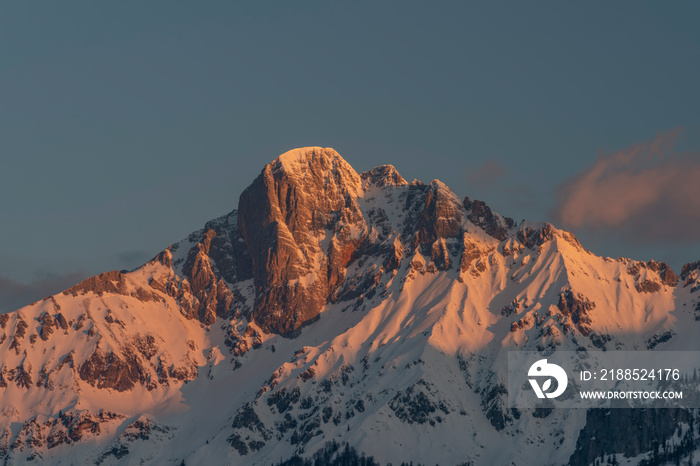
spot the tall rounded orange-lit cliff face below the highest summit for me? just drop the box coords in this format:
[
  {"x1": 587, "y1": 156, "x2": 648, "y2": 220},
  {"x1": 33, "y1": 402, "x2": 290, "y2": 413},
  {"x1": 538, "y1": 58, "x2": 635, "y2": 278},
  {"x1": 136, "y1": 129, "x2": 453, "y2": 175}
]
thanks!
[{"x1": 238, "y1": 148, "x2": 367, "y2": 334}]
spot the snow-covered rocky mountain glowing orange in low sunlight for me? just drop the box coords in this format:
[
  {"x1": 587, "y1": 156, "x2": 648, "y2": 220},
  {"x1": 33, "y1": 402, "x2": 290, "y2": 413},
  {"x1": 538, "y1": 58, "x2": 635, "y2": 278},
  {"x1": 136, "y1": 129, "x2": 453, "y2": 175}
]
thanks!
[{"x1": 0, "y1": 147, "x2": 700, "y2": 465}]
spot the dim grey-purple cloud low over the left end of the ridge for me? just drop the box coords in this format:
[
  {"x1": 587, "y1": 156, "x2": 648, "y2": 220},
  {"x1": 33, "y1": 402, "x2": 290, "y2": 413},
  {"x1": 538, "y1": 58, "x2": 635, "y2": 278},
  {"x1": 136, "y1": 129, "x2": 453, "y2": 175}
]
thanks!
[{"x1": 0, "y1": 272, "x2": 86, "y2": 314}]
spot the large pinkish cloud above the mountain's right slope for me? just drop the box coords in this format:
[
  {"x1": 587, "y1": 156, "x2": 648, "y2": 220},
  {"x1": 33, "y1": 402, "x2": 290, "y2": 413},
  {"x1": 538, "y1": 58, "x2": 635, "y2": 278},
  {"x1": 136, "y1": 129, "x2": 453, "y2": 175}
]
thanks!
[{"x1": 553, "y1": 128, "x2": 700, "y2": 242}]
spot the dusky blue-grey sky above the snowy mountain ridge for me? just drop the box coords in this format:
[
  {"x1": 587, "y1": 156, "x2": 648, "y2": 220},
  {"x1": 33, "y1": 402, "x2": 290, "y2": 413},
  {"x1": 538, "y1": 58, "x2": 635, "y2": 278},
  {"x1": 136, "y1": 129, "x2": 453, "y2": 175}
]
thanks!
[{"x1": 0, "y1": 1, "x2": 700, "y2": 310}]
